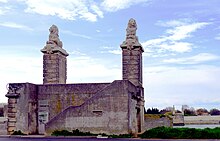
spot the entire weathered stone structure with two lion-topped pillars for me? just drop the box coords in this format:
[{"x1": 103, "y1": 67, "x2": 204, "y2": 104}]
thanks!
[{"x1": 6, "y1": 19, "x2": 144, "y2": 134}]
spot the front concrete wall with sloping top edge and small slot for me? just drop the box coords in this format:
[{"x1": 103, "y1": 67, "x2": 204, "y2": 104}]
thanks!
[{"x1": 46, "y1": 81, "x2": 137, "y2": 134}]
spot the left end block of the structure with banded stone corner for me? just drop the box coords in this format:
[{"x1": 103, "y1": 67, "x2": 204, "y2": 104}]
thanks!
[{"x1": 6, "y1": 83, "x2": 37, "y2": 134}]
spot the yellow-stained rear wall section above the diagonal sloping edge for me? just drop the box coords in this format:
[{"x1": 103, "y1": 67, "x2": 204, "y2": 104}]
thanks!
[{"x1": 38, "y1": 83, "x2": 110, "y2": 120}]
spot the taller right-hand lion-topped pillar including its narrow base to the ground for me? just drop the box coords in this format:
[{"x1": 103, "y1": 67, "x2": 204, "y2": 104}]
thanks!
[{"x1": 121, "y1": 18, "x2": 144, "y2": 132}]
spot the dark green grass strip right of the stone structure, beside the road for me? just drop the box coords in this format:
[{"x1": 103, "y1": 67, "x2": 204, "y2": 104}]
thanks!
[{"x1": 140, "y1": 127, "x2": 220, "y2": 139}]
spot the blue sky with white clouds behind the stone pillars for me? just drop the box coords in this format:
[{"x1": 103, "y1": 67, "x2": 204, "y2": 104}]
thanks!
[{"x1": 0, "y1": 0, "x2": 220, "y2": 109}]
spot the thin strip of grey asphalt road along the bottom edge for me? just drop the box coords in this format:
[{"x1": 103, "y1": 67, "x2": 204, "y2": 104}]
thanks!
[{"x1": 0, "y1": 137, "x2": 216, "y2": 141}]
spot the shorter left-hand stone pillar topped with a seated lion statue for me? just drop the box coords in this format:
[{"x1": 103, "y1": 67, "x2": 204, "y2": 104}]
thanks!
[{"x1": 41, "y1": 25, "x2": 69, "y2": 84}]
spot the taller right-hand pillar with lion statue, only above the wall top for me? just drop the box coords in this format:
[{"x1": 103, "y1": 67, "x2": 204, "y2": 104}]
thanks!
[{"x1": 121, "y1": 19, "x2": 144, "y2": 87}]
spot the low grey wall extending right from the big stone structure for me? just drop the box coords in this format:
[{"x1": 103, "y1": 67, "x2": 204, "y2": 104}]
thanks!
[{"x1": 144, "y1": 117, "x2": 173, "y2": 130}]
